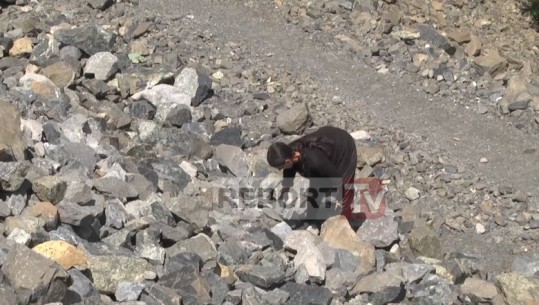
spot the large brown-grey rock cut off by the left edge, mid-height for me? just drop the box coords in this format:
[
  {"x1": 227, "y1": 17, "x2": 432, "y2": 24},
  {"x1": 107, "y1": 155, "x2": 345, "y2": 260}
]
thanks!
[{"x1": 0, "y1": 98, "x2": 26, "y2": 162}]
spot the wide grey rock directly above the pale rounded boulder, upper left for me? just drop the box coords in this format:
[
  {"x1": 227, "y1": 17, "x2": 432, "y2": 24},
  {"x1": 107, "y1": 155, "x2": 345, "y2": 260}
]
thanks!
[{"x1": 53, "y1": 24, "x2": 116, "y2": 56}]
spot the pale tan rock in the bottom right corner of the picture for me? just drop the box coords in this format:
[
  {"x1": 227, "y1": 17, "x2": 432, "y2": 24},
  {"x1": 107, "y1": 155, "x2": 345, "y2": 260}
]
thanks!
[{"x1": 496, "y1": 273, "x2": 539, "y2": 305}]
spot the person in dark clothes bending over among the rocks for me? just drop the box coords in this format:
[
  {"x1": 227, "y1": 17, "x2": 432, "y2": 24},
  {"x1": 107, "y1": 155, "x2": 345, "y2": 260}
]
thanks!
[{"x1": 267, "y1": 126, "x2": 357, "y2": 221}]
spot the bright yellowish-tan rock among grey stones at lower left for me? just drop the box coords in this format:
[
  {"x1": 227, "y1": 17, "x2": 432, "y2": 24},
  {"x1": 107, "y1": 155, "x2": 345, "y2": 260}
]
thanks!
[{"x1": 32, "y1": 240, "x2": 87, "y2": 270}]
